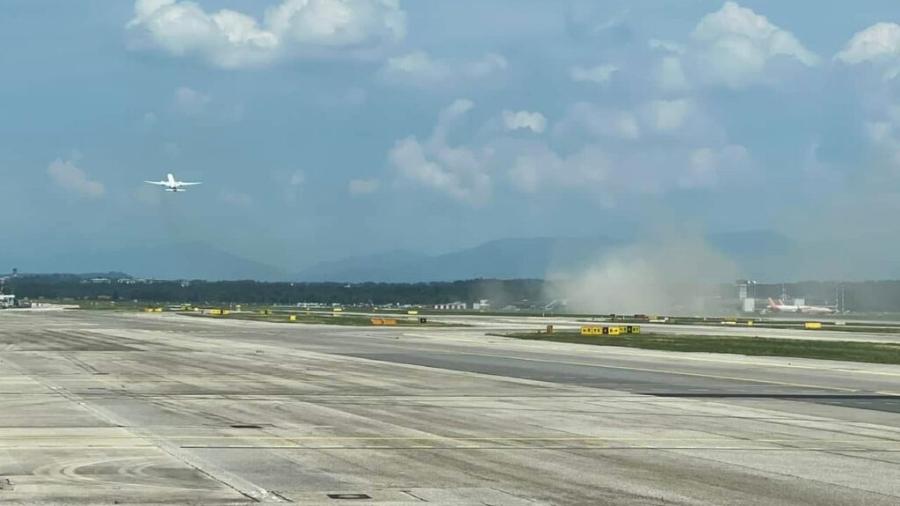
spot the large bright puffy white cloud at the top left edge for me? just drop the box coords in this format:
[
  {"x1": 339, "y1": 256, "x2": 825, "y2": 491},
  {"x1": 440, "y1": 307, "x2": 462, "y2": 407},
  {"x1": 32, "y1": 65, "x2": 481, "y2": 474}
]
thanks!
[{"x1": 126, "y1": 0, "x2": 406, "y2": 69}]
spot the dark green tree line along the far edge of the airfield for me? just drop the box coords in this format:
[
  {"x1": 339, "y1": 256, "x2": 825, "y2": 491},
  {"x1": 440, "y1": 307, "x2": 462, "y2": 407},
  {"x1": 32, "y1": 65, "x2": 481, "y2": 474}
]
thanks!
[{"x1": 5, "y1": 273, "x2": 900, "y2": 312}]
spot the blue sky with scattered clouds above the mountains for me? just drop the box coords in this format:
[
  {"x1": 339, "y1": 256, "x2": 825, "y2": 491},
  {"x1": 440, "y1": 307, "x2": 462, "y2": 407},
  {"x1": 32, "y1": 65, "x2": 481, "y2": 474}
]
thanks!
[{"x1": 0, "y1": 0, "x2": 900, "y2": 276}]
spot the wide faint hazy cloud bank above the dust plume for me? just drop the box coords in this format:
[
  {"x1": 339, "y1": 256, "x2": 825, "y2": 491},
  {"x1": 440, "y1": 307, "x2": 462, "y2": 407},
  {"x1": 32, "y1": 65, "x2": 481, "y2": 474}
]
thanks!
[{"x1": 528, "y1": 93, "x2": 752, "y2": 198}]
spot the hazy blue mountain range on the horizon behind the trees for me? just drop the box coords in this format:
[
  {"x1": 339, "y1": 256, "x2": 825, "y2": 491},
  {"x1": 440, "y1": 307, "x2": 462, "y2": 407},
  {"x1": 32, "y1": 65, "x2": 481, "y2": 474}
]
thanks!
[{"x1": 2, "y1": 231, "x2": 792, "y2": 282}]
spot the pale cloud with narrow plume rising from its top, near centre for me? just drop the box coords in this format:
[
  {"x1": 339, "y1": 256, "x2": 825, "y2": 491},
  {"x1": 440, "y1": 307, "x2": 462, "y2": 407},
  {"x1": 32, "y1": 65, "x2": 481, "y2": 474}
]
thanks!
[{"x1": 388, "y1": 100, "x2": 491, "y2": 205}]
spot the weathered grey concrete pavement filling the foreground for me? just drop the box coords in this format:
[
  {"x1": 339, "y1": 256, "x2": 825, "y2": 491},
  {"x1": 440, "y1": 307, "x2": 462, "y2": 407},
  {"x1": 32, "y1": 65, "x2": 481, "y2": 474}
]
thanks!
[{"x1": 0, "y1": 311, "x2": 900, "y2": 505}]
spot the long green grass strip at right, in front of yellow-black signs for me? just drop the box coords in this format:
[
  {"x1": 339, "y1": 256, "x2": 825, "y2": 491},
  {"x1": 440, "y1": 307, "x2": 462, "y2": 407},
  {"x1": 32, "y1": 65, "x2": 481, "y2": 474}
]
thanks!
[{"x1": 504, "y1": 332, "x2": 900, "y2": 364}]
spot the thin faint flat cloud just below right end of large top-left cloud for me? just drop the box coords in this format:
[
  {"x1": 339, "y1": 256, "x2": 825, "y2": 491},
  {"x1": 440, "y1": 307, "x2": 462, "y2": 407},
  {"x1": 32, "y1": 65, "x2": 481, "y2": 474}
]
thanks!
[{"x1": 379, "y1": 51, "x2": 508, "y2": 87}]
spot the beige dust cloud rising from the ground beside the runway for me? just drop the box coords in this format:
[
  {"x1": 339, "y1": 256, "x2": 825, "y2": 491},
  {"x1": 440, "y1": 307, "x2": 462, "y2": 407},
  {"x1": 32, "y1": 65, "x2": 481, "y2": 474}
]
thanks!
[{"x1": 548, "y1": 231, "x2": 739, "y2": 315}]
